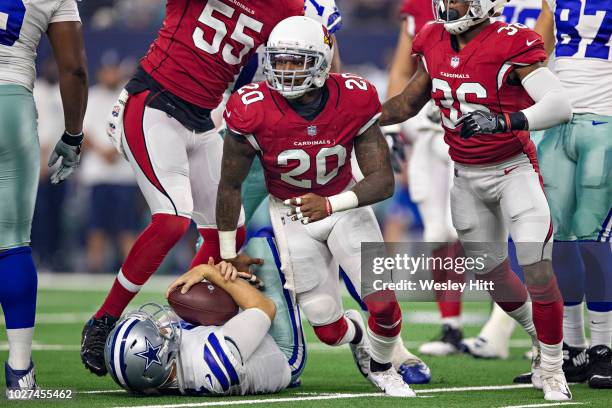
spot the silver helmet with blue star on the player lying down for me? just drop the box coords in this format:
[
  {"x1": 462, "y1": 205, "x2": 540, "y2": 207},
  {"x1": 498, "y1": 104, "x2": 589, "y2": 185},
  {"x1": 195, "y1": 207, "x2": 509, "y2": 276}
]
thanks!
[{"x1": 104, "y1": 303, "x2": 181, "y2": 393}]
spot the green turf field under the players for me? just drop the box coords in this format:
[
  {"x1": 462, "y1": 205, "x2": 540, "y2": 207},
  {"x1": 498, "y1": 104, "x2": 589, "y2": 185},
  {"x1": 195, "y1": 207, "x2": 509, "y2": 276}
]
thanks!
[{"x1": 0, "y1": 287, "x2": 612, "y2": 408}]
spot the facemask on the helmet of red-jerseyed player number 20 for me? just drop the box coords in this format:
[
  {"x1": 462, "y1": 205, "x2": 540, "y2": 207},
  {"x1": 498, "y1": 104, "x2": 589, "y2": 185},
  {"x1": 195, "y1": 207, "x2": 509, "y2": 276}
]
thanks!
[{"x1": 264, "y1": 47, "x2": 329, "y2": 99}]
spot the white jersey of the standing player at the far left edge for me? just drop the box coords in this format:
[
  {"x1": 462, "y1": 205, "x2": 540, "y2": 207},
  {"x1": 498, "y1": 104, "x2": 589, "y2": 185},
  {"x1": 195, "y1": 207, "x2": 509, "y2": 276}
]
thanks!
[{"x1": 0, "y1": 0, "x2": 81, "y2": 90}]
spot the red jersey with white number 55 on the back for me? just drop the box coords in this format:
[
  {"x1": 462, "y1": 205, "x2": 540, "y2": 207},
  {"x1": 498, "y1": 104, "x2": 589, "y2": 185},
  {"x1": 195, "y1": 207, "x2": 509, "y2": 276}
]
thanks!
[{"x1": 140, "y1": 0, "x2": 304, "y2": 109}]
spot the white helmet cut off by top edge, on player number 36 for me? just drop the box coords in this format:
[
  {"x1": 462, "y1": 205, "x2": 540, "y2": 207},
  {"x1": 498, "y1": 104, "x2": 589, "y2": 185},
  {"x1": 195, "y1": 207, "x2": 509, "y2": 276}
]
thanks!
[{"x1": 433, "y1": 0, "x2": 510, "y2": 35}]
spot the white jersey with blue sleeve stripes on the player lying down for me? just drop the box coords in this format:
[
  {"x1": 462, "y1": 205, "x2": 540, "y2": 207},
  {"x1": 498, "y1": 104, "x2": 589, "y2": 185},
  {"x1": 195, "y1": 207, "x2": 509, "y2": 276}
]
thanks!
[{"x1": 177, "y1": 326, "x2": 291, "y2": 395}]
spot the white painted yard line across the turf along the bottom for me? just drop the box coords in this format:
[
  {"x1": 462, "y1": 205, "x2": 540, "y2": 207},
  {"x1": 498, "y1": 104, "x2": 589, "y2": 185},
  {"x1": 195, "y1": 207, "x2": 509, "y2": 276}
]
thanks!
[{"x1": 97, "y1": 384, "x2": 531, "y2": 408}]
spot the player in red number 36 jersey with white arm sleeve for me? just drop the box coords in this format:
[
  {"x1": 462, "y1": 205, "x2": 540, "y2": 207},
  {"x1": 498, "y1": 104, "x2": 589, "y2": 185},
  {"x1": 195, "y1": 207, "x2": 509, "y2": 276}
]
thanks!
[{"x1": 381, "y1": 0, "x2": 572, "y2": 401}]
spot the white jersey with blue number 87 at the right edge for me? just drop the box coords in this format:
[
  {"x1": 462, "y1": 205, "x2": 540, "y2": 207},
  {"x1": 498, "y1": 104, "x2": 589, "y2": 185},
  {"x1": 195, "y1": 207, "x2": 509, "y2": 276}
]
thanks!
[{"x1": 547, "y1": 0, "x2": 612, "y2": 116}]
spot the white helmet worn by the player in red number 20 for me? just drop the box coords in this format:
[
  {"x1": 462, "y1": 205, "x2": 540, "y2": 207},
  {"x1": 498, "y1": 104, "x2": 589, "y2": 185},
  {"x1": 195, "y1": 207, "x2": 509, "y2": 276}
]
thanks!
[{"x1": 264, "y1": 16, "x2": 333, "y2": 99}]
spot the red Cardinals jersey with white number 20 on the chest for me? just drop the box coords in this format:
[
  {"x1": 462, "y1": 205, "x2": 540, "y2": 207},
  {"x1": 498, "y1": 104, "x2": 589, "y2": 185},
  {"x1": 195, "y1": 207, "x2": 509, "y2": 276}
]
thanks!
[{"x1": 224, "y1": 74, "x2": 382, "y2": 200}]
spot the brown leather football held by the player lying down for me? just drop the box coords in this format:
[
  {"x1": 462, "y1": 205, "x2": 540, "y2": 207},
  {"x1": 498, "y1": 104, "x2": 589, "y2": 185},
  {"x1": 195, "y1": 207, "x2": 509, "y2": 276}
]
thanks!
[{"x1": 168, "y1": 282, "x2": 238, "y2": 326}]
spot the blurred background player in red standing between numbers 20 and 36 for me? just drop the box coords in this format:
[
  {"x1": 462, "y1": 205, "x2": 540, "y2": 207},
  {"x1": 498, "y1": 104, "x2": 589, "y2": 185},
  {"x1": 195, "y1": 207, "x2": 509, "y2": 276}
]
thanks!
[{"x1": 383, "y1": 0, "x2": 466, "y2": 356}]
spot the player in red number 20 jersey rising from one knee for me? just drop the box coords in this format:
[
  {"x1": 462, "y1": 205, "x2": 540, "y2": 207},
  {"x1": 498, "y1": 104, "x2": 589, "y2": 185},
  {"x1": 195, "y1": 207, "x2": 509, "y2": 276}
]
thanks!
[{"x1": 217, "y1": 17, "x2": 415, "y2": 397}]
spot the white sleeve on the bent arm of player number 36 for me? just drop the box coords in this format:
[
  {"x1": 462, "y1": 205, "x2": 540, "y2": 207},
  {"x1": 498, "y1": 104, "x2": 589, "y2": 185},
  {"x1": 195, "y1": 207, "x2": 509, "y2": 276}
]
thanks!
[{"x1": 522, "y1": 67, "x2": 572, "y2": 130}]
